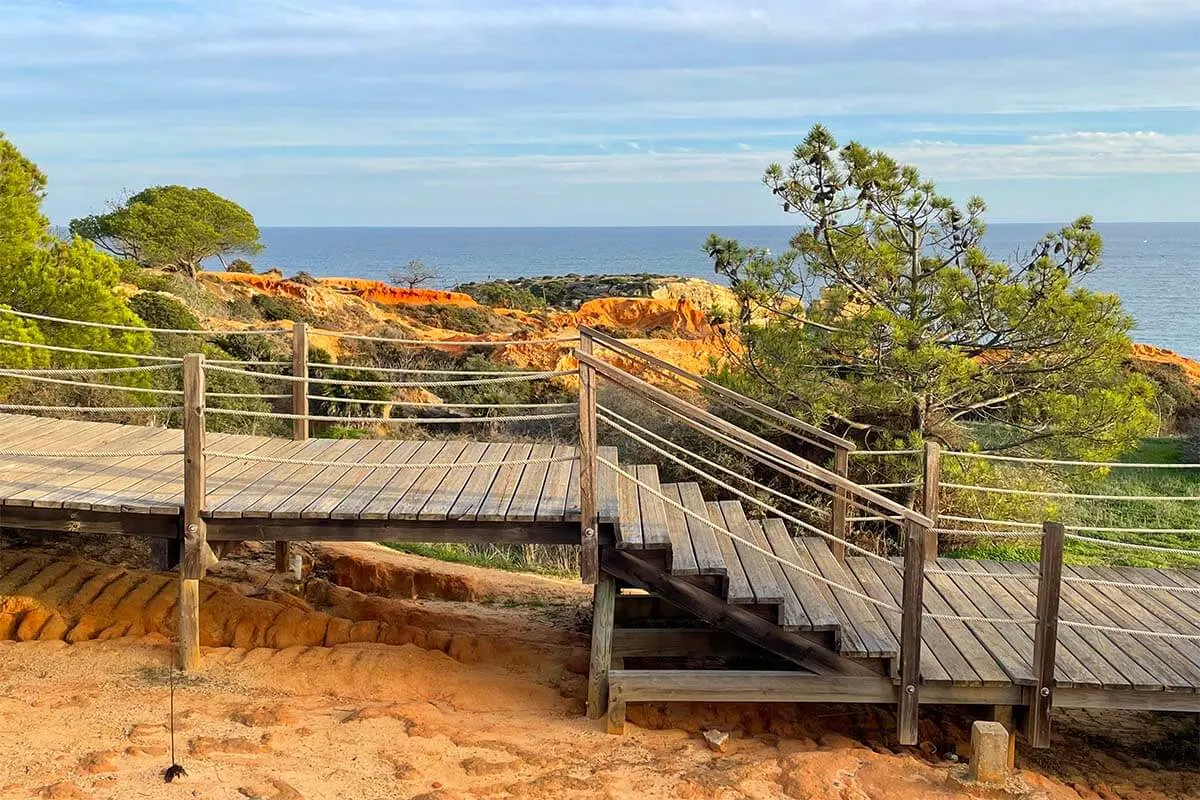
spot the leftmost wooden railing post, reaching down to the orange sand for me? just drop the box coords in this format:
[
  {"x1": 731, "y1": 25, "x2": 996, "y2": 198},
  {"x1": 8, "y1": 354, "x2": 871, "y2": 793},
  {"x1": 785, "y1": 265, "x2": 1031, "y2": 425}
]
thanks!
[{"x1": 179, "y1": 354, "x2": 208, "y2": 670}]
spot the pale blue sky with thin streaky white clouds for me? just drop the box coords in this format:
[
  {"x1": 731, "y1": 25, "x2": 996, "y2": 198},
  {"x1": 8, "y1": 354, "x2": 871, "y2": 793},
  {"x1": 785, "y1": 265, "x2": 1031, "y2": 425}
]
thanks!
[{"x1": 0, "y1": 0, "x2": 1200, "y2": 225}]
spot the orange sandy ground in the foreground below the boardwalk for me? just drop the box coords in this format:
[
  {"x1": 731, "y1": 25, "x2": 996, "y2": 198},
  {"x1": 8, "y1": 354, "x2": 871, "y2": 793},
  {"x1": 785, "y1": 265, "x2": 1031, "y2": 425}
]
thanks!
[{"x1": 0, "y1": 537, "x2": 1200, "y2": 800}]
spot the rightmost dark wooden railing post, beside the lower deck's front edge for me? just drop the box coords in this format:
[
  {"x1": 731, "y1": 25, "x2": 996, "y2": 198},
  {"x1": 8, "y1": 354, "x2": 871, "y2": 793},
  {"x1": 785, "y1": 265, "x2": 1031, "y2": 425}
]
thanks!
[{"x1": 1026, "y1": 522, "x2": 1066, "y2": 747}]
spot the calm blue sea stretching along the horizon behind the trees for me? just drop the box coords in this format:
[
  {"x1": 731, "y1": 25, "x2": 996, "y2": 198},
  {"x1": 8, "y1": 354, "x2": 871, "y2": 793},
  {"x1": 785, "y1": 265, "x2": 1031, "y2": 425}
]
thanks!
[{"x1": 243, "y1": 223, "x2": 1200, "y2": 359}]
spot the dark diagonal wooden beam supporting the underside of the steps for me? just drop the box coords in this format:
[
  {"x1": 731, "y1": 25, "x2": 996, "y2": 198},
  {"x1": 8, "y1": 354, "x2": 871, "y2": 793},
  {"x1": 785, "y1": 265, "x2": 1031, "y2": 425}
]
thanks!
[{"x1": 600, "y1": 548, "x2": 875, "y2": 676}]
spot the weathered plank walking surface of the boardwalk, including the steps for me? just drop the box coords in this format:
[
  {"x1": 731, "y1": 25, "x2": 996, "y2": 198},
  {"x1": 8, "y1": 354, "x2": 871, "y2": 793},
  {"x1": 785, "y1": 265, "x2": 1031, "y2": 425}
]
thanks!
[{"x1": 0, "y1": 414, "x2": 1200, "y2": 710}]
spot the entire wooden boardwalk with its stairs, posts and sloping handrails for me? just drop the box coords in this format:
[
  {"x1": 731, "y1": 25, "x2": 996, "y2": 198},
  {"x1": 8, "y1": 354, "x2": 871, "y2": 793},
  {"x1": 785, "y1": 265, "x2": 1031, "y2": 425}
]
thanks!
[{"x1": 0, "y1": 326, "x2": 1200, "y2": 746}]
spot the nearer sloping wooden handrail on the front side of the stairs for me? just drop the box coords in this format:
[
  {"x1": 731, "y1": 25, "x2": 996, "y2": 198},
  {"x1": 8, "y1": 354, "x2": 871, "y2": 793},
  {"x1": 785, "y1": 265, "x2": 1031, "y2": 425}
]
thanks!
[{"x1": 575, "y1": 350, "x2": 932, "y2": 528}]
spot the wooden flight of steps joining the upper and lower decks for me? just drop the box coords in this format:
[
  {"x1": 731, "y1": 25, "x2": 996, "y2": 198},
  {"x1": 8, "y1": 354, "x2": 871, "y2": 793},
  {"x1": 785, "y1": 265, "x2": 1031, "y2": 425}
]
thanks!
[{"x1": 599, "y1": 449, "x2": 899, "y2": 675}]
